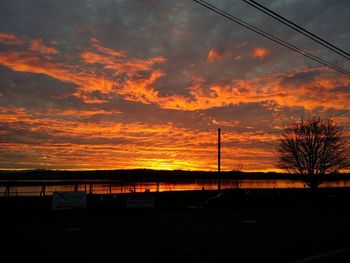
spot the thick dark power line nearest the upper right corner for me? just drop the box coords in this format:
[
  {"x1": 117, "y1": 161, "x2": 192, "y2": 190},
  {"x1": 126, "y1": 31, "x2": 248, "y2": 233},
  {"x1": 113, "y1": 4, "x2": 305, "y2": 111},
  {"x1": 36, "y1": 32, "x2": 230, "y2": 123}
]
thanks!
[{"x1": 242, "y1": 0, "x2": 350, "y2": 60}]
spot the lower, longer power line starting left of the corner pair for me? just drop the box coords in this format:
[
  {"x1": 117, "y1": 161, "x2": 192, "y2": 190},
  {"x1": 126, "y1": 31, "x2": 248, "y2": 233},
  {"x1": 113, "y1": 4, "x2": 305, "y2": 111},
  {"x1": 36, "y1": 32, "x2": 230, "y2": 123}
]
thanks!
[{"x1": 193, "y1": 0, "x2": 350, "y2": 76}]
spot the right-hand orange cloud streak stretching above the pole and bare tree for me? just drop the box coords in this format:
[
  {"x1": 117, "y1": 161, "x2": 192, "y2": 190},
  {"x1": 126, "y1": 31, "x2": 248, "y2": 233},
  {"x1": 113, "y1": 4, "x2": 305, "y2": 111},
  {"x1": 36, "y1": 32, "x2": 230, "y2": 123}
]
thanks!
[{"x1": 157, "y1": 69, "x2": 350, "y2": 110}]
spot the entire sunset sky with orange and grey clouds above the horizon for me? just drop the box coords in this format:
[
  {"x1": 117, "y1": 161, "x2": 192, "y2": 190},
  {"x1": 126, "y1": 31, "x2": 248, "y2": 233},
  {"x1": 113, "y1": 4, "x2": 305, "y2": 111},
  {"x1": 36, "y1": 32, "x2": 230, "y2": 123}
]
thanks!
[{"x1": 0, "y1": 0, "x2": 350, "y2": 171}]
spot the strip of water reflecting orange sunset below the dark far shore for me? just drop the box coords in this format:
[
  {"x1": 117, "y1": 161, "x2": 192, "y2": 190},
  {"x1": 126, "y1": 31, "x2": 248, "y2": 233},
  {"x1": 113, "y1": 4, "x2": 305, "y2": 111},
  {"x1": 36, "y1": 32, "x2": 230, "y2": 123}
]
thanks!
[{"x1": 0, "y1": 179, "x2": 350, "y2": 196}]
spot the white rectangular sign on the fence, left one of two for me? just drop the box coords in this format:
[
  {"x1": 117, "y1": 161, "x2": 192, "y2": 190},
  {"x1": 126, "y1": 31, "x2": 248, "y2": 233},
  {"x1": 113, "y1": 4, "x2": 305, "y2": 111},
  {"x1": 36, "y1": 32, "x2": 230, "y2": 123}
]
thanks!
[{"x1": 52, "y1": 192, "x2": 86, "y2": 210}]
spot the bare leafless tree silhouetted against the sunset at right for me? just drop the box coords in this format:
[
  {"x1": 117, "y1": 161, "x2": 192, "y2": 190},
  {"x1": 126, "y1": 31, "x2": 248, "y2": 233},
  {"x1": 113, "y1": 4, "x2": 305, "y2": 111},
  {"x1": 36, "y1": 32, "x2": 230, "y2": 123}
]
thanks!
[{"x1": 277, "y1": 118, "x2": 350, "y2": 188}]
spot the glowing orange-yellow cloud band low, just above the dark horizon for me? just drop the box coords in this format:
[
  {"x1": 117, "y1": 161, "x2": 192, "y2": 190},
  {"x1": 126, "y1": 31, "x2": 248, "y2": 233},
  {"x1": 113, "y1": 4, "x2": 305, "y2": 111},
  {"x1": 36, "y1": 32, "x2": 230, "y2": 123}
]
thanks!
[{"x1": 0, "y1": 108, "x2": 276, "y2": 170}]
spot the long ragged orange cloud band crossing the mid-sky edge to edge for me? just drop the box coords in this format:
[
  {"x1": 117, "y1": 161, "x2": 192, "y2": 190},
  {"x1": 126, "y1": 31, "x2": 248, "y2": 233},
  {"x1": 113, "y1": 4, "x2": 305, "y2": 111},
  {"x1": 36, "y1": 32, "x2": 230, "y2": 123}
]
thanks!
[{"x1": 0, "y1": 33, "x2": 349, "y2": 114}]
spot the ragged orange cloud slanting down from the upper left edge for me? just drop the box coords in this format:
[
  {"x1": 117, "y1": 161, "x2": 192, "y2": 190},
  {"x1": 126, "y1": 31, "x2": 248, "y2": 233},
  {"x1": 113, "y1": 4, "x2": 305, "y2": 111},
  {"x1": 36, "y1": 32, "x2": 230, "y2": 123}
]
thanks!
[{"x1": 0, "y1": 35, "x2": 166, "y2": 103}]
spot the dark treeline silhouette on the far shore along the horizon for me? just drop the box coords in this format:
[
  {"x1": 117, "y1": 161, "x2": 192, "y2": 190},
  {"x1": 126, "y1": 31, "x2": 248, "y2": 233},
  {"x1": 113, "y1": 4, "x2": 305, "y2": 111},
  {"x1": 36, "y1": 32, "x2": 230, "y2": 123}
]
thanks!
[{"x1": 0, "y1": 169, "x2": 350, "y2": 181}]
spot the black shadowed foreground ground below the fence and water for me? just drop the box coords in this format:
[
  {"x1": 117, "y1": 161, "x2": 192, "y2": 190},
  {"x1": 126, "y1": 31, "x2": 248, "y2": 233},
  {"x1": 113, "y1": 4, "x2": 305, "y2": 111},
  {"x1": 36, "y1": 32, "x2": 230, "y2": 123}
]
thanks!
[{"x1": 0, "y1": 189, "x2": 350, "y2": 262}]
